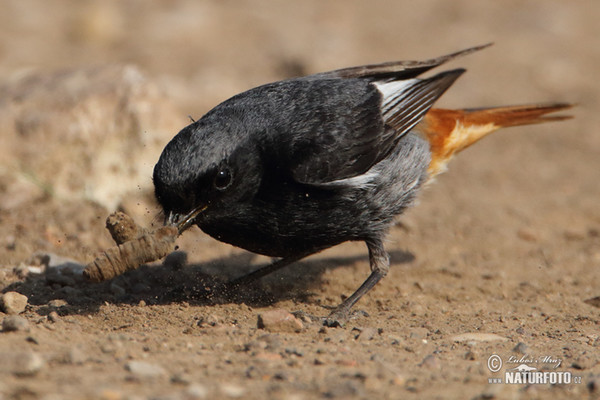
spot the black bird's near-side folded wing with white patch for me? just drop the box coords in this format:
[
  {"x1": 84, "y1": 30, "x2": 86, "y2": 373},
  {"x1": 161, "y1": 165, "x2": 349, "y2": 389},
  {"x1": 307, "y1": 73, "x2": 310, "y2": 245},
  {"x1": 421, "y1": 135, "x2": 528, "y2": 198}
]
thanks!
[{"x1": 286, "y1": 69, "x2": 464, "y2": 185}]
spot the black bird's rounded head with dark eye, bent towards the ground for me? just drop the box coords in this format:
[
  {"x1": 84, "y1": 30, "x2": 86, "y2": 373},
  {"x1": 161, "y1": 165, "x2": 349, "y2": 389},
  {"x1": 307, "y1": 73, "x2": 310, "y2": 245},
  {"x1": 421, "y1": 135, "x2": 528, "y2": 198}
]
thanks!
[{"x1": 153, "y1": 118, "x2": 262, "y2": 232}]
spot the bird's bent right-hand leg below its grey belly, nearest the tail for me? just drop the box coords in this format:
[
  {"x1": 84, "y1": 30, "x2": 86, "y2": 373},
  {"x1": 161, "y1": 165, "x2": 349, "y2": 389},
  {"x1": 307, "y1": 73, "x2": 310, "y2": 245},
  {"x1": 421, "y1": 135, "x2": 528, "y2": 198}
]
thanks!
[{"x1": 325, "y1": 239, "x2": 390, "y2": 326}]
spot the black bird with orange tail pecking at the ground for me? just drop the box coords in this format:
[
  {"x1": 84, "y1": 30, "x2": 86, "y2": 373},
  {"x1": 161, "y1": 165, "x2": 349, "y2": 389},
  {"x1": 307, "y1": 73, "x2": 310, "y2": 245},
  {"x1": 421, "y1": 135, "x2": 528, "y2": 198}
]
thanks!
[{"x1": 153, "y1": 44, "x2": 571, "y2": 326}]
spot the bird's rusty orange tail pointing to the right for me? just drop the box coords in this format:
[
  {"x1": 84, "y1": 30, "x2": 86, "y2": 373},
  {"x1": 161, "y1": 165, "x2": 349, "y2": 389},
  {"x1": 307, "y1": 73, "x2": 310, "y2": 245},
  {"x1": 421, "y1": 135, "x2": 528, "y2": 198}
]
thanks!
[{"x1": 417, "y1": 103, "x2": 572, "y2": 177}]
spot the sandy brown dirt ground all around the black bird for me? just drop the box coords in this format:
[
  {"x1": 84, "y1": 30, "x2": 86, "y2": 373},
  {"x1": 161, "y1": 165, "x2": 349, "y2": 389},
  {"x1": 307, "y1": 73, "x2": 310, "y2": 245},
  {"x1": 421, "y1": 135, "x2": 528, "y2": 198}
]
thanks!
[{"x1": 0, "y1": 0, "x2": 600, "y2": 400}]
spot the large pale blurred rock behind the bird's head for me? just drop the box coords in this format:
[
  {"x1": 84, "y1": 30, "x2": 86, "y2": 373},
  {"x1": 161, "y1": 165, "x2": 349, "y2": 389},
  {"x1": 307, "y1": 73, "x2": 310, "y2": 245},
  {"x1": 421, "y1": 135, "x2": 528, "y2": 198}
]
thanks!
[{"x1": 0, "y1": 65, "x2": 181, "y2": 209}]
